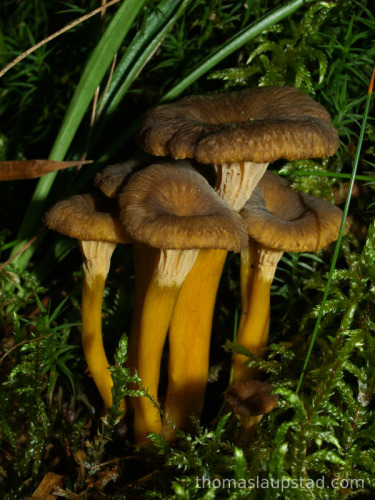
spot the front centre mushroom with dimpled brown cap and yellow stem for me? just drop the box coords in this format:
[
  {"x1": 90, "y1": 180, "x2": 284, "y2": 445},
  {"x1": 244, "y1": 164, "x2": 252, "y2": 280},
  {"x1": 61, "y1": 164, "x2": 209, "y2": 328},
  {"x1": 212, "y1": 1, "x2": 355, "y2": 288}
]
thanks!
[{"x1": 118, "y1": 164, "x2": 248, "y2": 442}]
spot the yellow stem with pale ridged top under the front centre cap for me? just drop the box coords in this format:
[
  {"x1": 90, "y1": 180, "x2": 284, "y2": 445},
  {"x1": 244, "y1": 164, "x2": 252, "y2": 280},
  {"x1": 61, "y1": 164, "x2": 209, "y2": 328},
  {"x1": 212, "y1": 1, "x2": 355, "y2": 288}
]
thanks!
[{"x1": 131, "y1": 245, "x2": 198, "y2": 443}]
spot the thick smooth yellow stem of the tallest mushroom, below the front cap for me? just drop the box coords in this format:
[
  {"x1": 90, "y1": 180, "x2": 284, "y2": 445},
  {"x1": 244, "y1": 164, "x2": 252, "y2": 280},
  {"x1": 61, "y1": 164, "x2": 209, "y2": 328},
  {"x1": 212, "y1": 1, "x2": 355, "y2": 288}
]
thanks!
[{"x1": 165, "y1": 249, "x2": 228, "y2": 439}]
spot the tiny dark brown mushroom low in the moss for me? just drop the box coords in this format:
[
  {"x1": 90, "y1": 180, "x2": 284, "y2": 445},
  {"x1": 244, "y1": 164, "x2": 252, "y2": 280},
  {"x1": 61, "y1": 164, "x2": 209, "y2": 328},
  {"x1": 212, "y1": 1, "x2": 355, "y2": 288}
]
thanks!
[{"x1": 225, "y1": 380, "x2": 279, "y2": 446}]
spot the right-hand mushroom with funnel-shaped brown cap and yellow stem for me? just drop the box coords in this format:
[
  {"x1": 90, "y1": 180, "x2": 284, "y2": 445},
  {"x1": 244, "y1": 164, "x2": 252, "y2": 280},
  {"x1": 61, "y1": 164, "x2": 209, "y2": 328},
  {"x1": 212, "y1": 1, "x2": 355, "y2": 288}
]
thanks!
[{"x1": 233, "y1": 172, "x2": 349, "y2": 381}]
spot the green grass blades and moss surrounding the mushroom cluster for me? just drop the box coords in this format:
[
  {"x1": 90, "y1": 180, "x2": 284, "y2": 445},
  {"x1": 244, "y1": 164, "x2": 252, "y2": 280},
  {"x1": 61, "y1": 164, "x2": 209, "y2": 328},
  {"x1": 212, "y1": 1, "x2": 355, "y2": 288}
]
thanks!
[{"x1": 0, "y1": 0, "x2": 375, "y2": 500}]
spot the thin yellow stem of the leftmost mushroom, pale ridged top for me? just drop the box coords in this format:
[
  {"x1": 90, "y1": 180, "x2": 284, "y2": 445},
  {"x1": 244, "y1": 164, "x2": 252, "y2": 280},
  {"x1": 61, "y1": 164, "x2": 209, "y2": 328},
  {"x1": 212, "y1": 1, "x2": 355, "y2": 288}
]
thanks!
[{"x1": 79, "y1": 241, "x2": 125, "y2": 412}]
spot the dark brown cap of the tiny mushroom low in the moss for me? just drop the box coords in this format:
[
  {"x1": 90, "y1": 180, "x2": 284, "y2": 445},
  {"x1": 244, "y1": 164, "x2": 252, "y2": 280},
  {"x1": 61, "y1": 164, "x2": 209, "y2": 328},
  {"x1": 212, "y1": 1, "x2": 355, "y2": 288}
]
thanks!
[{"x1": 225, "y1": 380, "x2": 279, "y2": 420}]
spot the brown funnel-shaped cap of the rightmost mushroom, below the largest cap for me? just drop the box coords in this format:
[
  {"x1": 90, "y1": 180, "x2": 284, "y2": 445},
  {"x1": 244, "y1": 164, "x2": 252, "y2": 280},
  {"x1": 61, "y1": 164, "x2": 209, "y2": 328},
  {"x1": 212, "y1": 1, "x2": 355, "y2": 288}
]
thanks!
[{"x1": 240, "y1": 172, "x2": 349, "y2": 252}]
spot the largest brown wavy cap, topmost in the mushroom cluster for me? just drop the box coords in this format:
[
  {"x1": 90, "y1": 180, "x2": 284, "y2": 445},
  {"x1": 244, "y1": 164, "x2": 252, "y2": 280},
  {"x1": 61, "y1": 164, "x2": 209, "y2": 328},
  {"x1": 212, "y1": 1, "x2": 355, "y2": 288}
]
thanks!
[{"x1": 137, "y1": 86, "x2": 339, "y2": 164}]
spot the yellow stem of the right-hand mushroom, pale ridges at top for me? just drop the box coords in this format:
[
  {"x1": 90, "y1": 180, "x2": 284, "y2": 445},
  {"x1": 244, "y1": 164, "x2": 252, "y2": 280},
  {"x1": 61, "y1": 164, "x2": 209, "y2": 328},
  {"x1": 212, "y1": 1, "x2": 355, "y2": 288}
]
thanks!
[{"x1": 232, "y1": 244, "x2": 283, "y2": 382}]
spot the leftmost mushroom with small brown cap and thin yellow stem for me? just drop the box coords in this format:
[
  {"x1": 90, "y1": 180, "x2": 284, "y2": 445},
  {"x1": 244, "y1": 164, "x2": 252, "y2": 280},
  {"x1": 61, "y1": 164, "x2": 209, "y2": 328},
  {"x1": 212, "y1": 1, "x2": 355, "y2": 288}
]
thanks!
[{"x1": 45, "y1": 194, "x2": 131, "y2": 411}]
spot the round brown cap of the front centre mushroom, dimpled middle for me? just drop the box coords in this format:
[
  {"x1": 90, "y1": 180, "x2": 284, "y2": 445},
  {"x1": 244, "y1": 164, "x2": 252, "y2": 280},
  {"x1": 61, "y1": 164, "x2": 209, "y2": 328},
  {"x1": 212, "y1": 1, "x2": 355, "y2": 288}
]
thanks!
[{"x1": 118, "y1": 164, "x2": 248, "y2": 252}]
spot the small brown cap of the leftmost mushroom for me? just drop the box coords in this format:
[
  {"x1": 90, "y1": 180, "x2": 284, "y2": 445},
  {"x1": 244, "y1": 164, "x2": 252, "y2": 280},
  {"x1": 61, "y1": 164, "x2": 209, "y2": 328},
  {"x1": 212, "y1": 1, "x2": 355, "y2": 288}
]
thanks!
[{"x1": 44, "y1": 194, "x2": 132, "y2": 243}]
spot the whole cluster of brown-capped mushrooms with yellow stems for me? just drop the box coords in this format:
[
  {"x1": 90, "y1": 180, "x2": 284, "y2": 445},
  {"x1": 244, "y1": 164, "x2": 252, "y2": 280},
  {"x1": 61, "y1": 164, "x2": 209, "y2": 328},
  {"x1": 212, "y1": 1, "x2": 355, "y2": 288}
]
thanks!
[{"x1": 45, "y1": 86, "x2": 350, "y2": 443}]
